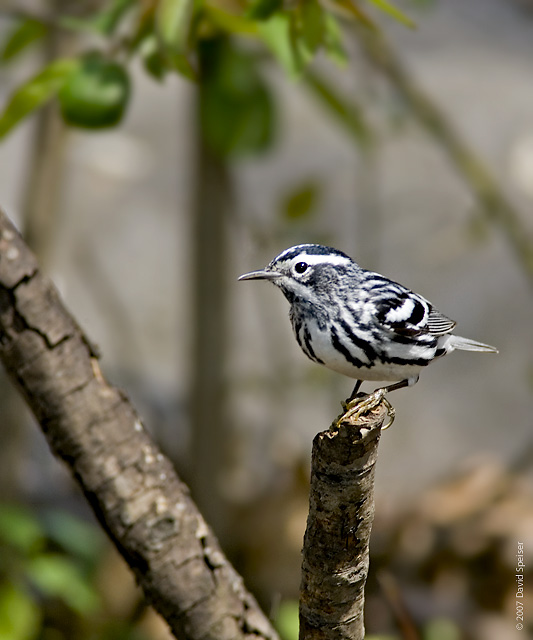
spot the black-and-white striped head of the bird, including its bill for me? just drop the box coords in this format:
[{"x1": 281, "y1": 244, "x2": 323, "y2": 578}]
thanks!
[{"x1": 239, "y1": 244, "x2": 356, "y2": 304}]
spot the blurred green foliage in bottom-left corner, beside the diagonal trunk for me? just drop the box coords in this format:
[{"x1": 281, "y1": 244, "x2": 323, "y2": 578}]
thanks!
[{"x1": 0, "y1": 504, "x2": 148, "y2": 640}]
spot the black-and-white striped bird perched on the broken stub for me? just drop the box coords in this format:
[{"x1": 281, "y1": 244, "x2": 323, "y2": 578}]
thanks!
[{"x1": 238, "y1": 244, "x2": 498, "y2": 426}]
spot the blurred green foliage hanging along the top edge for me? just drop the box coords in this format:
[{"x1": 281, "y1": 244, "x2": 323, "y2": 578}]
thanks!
[{"x1": 0, "y1": 0, "x2": 412, "y2": 145}]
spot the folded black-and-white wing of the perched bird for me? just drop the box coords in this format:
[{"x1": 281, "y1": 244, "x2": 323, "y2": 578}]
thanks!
[{"x1": 375, "y1": 285, "x2": 455, "y2": 336}]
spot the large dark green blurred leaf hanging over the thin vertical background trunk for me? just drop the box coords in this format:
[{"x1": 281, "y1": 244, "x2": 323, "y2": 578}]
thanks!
[{"x1": 200, "y1": 39, "x2": 275, "y2": 157}]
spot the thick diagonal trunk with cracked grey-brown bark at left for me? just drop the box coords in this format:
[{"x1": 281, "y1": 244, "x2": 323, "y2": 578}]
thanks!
[{"x1": 0, "y1": 210, "x2": 277, "y2": 640}]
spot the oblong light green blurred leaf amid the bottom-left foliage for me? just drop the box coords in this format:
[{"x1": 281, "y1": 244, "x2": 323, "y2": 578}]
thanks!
[{"x1": 26, "y1": 553, "x2": 100, "y2": 615}]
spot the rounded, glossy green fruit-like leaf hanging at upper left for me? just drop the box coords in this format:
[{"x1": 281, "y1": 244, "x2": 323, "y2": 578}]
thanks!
[{"x1": 58, "y1": 52, "x2": 130, "y2": 129}]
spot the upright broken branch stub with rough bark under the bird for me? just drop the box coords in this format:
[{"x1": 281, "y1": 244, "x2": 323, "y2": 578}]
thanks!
[{"x1": 300, "y1": 405, "x2": 386, "y2": 640}]
